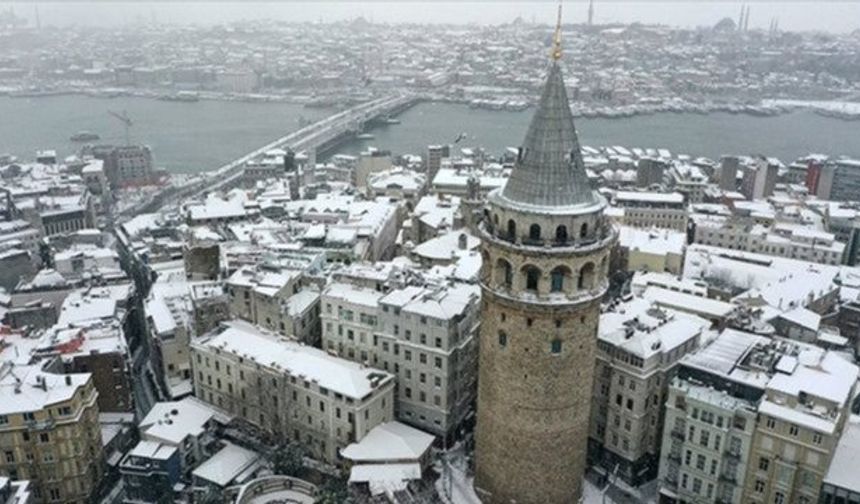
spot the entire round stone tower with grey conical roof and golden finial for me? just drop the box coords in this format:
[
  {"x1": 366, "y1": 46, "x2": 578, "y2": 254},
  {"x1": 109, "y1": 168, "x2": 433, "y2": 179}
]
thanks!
[{"x1": 475, "y1": 1, "x2": 616, "y2": 504}]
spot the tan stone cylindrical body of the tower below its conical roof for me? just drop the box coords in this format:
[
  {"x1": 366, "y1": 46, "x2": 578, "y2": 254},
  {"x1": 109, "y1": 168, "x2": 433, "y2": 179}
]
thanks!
[{"x1": 475, "y1": 215, "x2": 615, "y2": 504}]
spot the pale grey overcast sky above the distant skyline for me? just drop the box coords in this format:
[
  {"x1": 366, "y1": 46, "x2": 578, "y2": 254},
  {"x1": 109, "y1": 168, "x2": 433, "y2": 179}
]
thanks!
[{"x1": 5, "y1": 0, "x2": 860, "y2": 32}]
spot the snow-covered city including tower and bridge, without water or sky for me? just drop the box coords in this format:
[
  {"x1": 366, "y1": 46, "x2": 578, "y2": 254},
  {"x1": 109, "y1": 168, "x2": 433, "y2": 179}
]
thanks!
[{"x1": 0, "y1": 3, "x2": 860, "y2": 504}]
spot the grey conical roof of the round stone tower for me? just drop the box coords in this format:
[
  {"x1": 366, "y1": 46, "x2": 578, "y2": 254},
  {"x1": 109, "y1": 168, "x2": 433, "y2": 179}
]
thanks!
[{"x1": 502, "y1": 61, "x2": 598, "y2": 207}]
